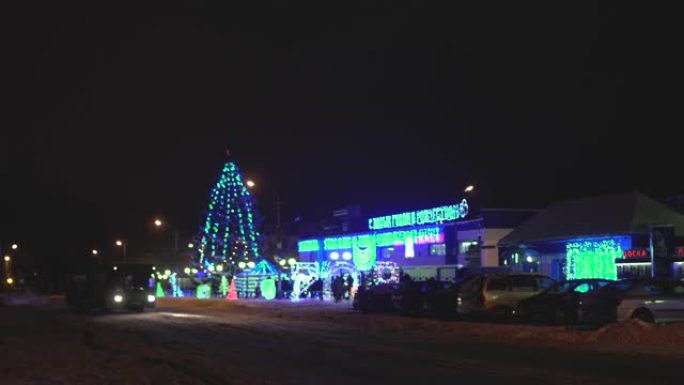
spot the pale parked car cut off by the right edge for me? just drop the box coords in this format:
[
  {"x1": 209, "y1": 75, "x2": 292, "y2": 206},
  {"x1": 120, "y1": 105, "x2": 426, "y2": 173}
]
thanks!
[{"x1": 579, "y1": 278, "x2": 684, "y2": 324}]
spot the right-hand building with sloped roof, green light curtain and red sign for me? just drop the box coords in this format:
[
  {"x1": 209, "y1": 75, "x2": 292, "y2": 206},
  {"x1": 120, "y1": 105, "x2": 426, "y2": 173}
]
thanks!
[{"x1": 498, "y1": 193, "x2": 684, "y2": 279}]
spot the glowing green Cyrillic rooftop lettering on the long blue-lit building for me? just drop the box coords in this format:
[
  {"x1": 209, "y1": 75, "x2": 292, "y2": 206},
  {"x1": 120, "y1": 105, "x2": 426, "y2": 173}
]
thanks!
[{"x1": 368, "y1": 199, "x2": 468, "y2": 230}]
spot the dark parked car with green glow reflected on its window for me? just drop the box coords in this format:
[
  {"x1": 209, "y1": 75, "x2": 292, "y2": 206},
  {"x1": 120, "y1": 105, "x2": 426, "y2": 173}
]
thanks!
[{"x1": 515, "y1": 279, "x2": 613, "y2": 324}]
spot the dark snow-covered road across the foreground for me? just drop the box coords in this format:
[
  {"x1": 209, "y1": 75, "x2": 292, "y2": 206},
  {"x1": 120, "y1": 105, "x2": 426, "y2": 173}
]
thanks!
[{"x1": 0, "y1": 300, "x2": 684, "y2": 385}]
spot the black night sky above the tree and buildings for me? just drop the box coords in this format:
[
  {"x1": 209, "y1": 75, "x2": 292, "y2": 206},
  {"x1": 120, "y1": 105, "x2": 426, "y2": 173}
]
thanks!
[{"x1": 0, "y1": 1, "x2": 684, "y2": 266}]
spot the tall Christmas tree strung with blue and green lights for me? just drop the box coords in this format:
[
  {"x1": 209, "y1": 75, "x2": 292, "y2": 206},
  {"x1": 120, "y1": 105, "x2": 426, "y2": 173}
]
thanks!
[{"x1": 199, "y1": 154, "x2": 260, "y2": 268}]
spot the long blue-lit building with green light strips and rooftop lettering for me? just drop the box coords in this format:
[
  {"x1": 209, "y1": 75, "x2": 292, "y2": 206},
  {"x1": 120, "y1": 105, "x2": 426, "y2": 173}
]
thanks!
[{"x1": 298, "y1": 199, "x2": 536, "y2": 280}]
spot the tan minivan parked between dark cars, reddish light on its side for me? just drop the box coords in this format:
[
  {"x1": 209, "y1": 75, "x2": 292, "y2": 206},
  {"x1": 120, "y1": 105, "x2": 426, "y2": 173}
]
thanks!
[{"x1": 456, "y1": 273, "x2": 556, "y2": 319}]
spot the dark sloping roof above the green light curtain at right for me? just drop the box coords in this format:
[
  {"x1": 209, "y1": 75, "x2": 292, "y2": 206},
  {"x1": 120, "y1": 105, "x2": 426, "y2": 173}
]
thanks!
[{"x1": 499, "y1": 192, "x2": 684, "y2": 246}]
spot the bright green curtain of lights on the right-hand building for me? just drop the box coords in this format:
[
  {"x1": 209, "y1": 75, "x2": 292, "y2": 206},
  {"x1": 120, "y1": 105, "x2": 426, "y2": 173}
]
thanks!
[{"x1": 565, "y1": 239, "x2": 623, "y2": 280}]
